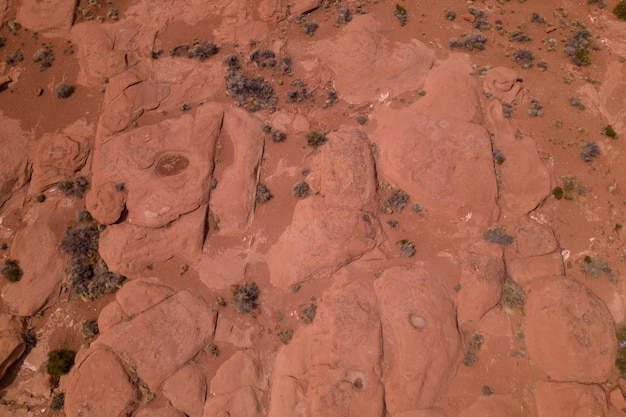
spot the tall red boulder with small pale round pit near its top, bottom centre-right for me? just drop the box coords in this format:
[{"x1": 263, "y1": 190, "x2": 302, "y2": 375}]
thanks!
[{"x1": 374, "y1": 267, "x2": 461, "y2": 415}]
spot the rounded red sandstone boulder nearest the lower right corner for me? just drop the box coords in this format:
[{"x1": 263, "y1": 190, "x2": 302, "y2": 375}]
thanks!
[{"x1": 525, "y1": 277, "x2": 617, "y2": 384}]
